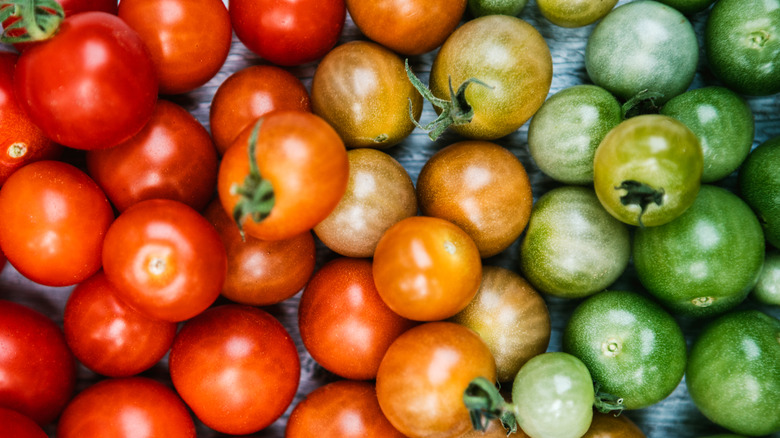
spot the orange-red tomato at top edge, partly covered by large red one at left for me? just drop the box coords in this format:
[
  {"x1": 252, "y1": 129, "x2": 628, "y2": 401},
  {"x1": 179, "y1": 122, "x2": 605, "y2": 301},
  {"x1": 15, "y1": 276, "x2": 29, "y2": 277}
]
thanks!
[{"x1": 119, "y1": 0, "x2": 233, "y2": 94}]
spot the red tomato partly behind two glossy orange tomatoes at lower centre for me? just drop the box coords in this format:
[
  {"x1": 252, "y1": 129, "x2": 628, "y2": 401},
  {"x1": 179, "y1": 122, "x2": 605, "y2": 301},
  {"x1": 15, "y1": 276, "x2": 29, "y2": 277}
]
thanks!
[{"x1": 298, "y1": 258, "x2": 415, "y2": 380}]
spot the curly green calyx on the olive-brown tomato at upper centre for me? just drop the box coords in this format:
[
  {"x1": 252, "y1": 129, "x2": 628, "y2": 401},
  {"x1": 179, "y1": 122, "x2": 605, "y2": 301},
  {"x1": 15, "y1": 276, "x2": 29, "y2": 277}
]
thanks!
[{"x1": 404, "y1": 59, "x2": 493, "y2": 140}]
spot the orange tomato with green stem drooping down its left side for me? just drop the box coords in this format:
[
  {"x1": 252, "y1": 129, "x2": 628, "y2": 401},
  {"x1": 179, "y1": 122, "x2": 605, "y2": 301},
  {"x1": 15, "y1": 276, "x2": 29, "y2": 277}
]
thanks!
[{"x1": 217, "y1": 111, "x2": 349, "y2": 240}]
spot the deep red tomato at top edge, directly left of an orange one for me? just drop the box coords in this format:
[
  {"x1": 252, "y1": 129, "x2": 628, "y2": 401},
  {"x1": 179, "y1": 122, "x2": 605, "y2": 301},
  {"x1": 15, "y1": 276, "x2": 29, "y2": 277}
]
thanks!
[{"x1": 229, "y1": 0, "x2": 347, "y2": 66}]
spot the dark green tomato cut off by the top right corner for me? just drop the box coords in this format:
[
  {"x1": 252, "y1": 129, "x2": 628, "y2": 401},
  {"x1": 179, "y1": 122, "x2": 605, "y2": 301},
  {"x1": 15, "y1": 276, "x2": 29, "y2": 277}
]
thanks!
[{"x1": 704, "y1": 0, "x2": 780, "y2": 96}]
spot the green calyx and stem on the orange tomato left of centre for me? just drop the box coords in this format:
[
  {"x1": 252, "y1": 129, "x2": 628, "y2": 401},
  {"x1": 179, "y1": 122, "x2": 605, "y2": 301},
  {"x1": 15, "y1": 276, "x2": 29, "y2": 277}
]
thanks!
[{"x1": 230, "y1": 119, "x2": 276, "y2": 239}]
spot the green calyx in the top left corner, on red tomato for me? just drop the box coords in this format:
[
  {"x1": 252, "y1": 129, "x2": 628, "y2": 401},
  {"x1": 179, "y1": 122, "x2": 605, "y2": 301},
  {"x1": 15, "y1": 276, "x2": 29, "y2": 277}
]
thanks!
[{"x1": 0, "y1": 0, "x2": 65, "y2": 44}]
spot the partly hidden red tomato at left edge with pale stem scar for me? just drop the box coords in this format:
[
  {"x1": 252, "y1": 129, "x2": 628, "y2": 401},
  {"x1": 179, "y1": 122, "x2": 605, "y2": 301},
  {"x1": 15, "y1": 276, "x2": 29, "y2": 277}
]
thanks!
[{"x1": 0, "y1": 52, "x2": 62, "y2": 185}]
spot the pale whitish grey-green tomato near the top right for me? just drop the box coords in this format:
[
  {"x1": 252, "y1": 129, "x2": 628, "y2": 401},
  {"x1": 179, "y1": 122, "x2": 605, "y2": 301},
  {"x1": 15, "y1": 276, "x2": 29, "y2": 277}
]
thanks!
[{"x1": 585, "y1": 0, "x2": 699, "y2": 104}]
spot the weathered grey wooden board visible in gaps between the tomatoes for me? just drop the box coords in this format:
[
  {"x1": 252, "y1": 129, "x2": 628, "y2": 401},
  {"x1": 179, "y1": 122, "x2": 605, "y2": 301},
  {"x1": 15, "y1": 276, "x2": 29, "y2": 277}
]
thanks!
[{"x1": 0, "y1": 0, "x2": 780, "y2": 438}]
